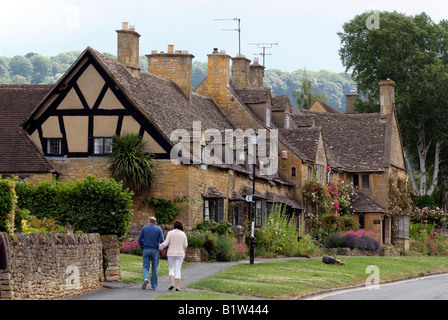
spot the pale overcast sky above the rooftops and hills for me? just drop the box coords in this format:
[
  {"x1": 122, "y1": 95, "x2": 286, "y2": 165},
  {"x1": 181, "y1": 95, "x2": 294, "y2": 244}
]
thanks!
[{"x1": 0, "y1": 0, "x2": 448, "y2": 72}]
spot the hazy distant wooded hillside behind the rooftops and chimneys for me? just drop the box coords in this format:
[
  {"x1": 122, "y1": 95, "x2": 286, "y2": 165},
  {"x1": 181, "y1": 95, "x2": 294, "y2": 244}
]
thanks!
[{"x1": 0, "y1": 51, "x2": 355, "y2": 111}]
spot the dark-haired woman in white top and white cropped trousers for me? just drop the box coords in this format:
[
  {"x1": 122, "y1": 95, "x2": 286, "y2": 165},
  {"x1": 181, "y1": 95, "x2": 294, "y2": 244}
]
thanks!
[{"x1": 159, "y1": 220, "x2": 188, "y2": 291}]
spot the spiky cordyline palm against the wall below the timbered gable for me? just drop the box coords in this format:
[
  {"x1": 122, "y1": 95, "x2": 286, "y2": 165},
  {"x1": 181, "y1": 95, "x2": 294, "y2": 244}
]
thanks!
[{"x1": 109, "y1": 133, "x2": 156, "y2": 191}]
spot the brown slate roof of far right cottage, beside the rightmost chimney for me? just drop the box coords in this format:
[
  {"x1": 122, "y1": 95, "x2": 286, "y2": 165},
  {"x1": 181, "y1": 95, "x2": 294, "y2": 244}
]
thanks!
[{"x1": 293, "y1": 110, "x2": 389, "y2": 172}]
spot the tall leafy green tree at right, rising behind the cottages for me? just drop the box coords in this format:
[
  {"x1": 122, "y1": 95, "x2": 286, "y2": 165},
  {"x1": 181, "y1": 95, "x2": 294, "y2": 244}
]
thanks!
[{"x1": 338, "y1": 12, "x2": 448, "y2": 195}]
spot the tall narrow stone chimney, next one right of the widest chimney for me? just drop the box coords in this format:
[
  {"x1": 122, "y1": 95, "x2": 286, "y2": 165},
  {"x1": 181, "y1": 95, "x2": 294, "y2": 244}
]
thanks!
[{"x1": 207, "y1": 48, "x2": 230, "y2": 105}]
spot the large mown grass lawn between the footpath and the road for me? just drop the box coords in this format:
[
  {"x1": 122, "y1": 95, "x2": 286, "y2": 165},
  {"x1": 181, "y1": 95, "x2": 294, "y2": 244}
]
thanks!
[{"x1": 189, "y1": 257, "x2": 448, "y2": 299}]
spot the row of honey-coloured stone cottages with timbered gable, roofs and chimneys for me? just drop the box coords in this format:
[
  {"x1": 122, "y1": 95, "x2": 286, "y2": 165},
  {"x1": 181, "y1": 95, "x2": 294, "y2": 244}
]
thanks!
[{"x1": 0, "y1": 23, "x2": 405, "y2": 248}]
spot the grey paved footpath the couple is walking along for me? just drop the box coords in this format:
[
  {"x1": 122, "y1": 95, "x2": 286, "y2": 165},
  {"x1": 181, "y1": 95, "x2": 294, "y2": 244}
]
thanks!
[{"x1": 71, "y1": 260, "x2": 252, "y2": 300}]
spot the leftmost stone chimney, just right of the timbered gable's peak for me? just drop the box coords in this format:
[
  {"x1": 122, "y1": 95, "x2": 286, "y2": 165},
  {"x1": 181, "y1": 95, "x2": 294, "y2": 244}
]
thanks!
[{"x1": 116, "y1": 22, "x2": 140, "y2": 77}]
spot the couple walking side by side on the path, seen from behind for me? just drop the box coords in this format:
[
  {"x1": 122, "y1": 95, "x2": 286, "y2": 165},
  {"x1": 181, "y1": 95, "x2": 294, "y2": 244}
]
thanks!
[{"x1": 138, "y1": 217, "x2": 188, "y2": 291}]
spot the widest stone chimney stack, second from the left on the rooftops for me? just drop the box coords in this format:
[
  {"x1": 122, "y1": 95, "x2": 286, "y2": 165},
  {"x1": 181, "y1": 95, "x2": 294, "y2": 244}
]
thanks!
[{"x1": 146, "y1": 44, "x2": 194, "y2": 101}]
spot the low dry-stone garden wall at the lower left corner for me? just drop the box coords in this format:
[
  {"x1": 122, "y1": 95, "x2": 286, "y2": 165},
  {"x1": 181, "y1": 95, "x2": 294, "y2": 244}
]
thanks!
[{"x1": 0, "y1": 233, "x2": 103, "y2": 300}]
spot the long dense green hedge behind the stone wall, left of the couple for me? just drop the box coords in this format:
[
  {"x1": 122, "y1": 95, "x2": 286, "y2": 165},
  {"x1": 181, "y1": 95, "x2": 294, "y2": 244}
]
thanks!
[{"x1": 16, "y1": 175, "x2": 132, "y2": 237}]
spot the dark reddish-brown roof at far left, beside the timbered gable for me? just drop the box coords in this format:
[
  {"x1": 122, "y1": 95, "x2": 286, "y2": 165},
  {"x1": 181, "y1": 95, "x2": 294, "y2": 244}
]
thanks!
[{"x1": 0, "y1": 85, "x2": 55, "y2": 173}]
